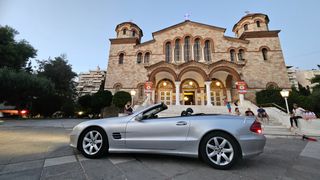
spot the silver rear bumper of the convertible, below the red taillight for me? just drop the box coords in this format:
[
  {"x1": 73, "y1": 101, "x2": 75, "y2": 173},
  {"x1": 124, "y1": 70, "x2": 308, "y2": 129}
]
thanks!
[{"x1": 239, "y1": 133, "x2": 266, "y2": 158}]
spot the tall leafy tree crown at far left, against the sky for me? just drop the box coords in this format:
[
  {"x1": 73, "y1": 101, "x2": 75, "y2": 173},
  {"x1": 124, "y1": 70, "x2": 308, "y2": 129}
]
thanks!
[{"x1": 0, "y1": 26, "x2": 37, "y2": 70}]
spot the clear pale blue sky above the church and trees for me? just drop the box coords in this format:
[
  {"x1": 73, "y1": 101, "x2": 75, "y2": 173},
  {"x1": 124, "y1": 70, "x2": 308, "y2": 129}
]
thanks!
[{"x1": 0, "y1": 0, "x2": 320, "y2": 73}]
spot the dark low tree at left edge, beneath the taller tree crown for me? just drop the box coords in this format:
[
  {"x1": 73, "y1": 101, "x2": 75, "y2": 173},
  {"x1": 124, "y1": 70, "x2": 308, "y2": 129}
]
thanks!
[{"x1": 0, "y1": 68, "x2": 54, "y2": 109}]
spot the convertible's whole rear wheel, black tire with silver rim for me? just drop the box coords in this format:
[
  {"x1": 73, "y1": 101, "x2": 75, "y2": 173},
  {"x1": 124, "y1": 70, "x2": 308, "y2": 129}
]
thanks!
[{"x1": 199, "y1": 131, "x2": 241, "y2": 170}]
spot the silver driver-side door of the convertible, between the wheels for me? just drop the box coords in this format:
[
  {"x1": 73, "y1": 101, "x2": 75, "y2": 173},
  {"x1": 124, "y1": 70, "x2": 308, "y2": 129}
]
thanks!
[{"x1": 126, "y1": 117, "x2": 190, "y2": 150}]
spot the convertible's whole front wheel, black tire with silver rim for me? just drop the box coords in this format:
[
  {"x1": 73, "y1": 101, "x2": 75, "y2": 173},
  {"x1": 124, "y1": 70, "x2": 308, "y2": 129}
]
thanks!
[{"x1": 78, "y1": 127, "x2": 109, "y2": 159}]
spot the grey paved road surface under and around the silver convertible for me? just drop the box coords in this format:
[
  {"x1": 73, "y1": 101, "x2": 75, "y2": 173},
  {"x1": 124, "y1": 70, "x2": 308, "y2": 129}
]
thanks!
[{"x1": 0, "y1": 120, "x2": 320, "y2": 180}]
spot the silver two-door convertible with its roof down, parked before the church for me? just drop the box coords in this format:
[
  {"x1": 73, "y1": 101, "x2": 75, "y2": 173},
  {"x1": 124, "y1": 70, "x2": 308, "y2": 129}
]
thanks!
[{"x1": 70, "y1": 103, "x2": 266, "y2": 169}]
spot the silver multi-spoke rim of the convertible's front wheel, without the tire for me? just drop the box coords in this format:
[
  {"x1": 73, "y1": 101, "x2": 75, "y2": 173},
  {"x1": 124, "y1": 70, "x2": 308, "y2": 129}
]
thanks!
[{"x1": 82, "y1": 130, "x2": 102, "y2": 155}]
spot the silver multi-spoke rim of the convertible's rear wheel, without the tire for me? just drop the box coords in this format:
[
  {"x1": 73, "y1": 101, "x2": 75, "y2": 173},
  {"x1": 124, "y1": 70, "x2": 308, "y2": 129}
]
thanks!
[{"x1": 206, "y1": 137, "x2": 234, "y2": 166}]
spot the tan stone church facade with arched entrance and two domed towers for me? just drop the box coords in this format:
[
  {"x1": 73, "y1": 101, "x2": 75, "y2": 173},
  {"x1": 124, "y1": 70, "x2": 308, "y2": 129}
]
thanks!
[{"x1": 105, "y1": 14, "x2": 290, "y2": 105}]
